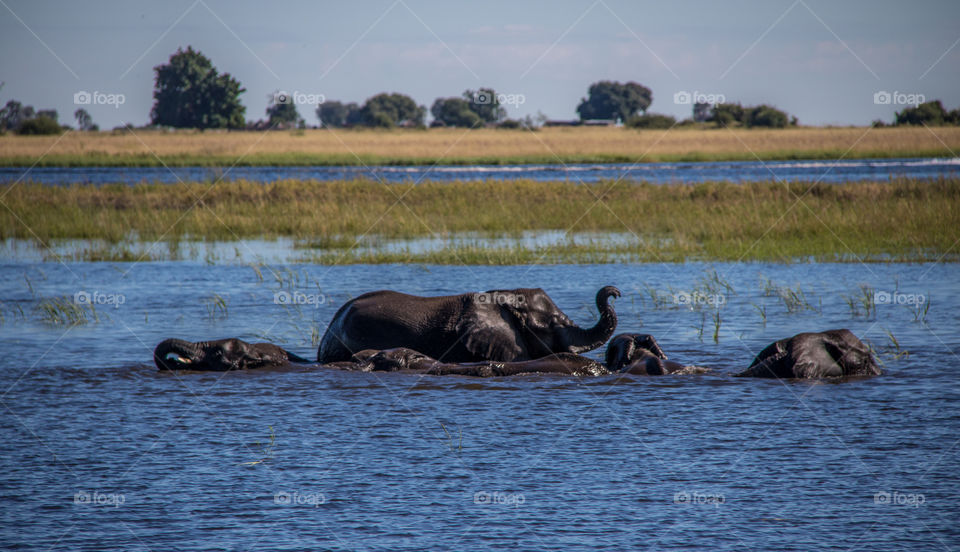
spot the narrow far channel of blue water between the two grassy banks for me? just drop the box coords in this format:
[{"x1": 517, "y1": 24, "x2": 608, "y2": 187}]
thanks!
[{"x1": 0, "y1": 158, "x2": 960, "y2": 186}]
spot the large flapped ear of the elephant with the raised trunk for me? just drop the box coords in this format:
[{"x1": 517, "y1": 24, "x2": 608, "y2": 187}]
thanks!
[{"x1": 457, "y1": 303, "x2": 523, "y2": 361}]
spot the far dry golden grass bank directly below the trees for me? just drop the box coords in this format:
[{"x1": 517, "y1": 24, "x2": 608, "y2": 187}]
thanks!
[{"x1": 0, "y1": 127, "x2": 960, "y2": 166}]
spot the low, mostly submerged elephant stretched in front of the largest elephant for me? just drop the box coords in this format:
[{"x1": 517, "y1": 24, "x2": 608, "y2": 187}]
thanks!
[{"x1": 338, "y1": 347, "x2": 610, "y2": 377}]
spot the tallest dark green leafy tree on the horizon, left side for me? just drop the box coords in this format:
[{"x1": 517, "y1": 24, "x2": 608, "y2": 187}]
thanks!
[{"x1": 150, "y1": 46, "x2": 246, "y2": 129}]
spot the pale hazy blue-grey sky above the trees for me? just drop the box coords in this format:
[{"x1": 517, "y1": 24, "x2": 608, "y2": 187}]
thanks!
[{"x1": 0, "y1": 0, "x2": 960, "y2": 128}]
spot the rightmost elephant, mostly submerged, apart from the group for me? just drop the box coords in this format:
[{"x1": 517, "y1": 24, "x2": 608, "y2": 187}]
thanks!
[{"x1": 735, "y1": 329, "x2": 881, "y2": 378}]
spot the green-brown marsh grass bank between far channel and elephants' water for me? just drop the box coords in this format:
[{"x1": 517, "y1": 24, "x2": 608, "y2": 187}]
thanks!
[{"x1": 0, "y1": 178, "x2": 960, "y2": 264}]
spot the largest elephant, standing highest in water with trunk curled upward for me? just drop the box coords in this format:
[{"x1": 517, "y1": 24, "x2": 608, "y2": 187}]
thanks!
[{"x1": 317, "y1": 286, "x2": 620, "y2": 364}]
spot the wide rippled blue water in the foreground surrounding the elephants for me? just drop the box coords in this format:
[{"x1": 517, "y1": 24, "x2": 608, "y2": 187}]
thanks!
[{"x1": 0, "y1": 260, "x2": 960, "y2": 551}]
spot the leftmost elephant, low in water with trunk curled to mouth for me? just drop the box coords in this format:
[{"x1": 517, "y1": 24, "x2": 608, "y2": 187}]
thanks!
[{"x1": 153, "y1": 338, "x2": 311, "y2": 372}]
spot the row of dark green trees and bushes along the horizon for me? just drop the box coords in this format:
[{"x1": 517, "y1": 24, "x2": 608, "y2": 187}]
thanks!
[{"x1": 0, "y1": 46, "x2": 960, "y2": 134}]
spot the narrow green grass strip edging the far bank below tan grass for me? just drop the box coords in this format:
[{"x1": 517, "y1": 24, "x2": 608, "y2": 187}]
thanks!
[{"x1": 0, "y1": 148, "x2": 953, "y2": 167}]
